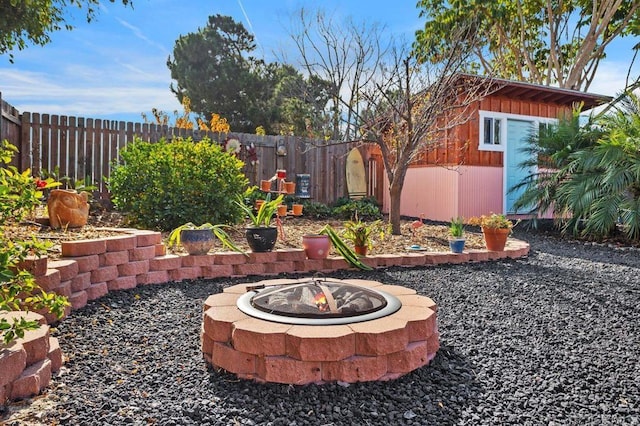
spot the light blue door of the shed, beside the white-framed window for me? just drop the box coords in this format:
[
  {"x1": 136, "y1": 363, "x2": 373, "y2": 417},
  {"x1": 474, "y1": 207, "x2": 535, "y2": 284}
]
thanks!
[{"x1": 505, "y1": 119, "x2": 534, "y2": 214}]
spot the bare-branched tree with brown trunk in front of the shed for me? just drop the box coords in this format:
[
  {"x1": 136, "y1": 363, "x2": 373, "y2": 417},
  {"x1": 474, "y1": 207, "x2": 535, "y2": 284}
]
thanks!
[{"x1": 358, "y1": 26, "x2": 497, "y2": 235}]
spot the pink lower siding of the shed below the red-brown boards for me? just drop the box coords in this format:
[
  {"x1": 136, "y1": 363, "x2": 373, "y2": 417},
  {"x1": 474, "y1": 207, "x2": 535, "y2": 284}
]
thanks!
[{"x1": 383, "y1": 166, "x2": 503, "y2": 222}]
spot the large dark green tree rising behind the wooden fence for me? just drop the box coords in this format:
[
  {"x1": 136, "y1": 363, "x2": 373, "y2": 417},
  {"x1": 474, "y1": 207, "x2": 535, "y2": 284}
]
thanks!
[{"x1": 167, "y1": 15, "x2": 328, "y2": 135}]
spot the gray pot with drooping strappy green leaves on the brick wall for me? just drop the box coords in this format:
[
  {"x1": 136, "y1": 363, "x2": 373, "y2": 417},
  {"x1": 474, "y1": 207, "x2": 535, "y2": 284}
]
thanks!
[{"x1": 167, "y1": 222, "x2": 242, "y2": 255}]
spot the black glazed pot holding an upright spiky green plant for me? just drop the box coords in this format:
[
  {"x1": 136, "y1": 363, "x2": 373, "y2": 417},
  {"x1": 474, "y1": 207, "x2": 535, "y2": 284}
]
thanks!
[{"x1": 236, "y1": 194, "x2": 284, "y2": 252}]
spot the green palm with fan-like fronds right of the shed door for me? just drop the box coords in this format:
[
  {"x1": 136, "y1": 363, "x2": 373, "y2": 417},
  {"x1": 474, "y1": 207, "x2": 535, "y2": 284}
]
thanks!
[{"x1": 556, "y1": 93, "x2": 640, "y2": 239}]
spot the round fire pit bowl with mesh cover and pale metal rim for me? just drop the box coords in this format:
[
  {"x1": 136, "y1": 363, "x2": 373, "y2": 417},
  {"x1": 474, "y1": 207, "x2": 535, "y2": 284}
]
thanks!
[{"x1": 238, "y1": 278, "x2": 402, "y2": 325}]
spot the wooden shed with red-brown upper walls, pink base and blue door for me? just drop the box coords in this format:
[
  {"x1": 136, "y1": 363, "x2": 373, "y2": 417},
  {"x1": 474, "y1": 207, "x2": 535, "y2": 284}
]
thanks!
[{"x1": 383, "y1": 77, "x2": 611, "y2": 221}]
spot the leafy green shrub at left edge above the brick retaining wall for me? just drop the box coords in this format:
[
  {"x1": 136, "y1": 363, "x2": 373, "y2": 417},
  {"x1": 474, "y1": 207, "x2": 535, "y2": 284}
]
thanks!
[{"x1": 0, "y1": 140, "x2": 69, "y2": 343}]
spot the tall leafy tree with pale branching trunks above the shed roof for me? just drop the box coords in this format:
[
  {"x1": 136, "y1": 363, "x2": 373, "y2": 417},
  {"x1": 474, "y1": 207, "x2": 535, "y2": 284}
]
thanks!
[{"x1": 414, "y1": 0, "x2": 640, "y2": 91}]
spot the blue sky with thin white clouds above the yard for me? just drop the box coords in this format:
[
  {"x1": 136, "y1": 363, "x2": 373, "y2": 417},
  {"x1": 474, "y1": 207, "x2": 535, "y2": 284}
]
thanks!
[{"x1": 0, "y1": 0, "x2": 640, "y2": 122}]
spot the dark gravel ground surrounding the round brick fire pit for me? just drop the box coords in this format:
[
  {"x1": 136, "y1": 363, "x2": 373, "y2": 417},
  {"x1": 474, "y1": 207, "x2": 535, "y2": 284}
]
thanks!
[{"x1": 4, "y1": 231, "x2": 640, "y2": 425}]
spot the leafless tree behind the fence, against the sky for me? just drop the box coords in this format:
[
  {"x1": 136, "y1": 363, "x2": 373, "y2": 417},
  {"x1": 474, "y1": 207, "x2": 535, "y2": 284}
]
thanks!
[{"x1": 288, "y1": 9, "x2": 387, "y2": 141}]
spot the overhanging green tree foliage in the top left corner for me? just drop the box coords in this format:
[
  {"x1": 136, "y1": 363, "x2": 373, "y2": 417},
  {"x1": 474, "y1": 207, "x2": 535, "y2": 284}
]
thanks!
[{"x1": 0, "y1": 0, "x2": 132, "y2": 58}]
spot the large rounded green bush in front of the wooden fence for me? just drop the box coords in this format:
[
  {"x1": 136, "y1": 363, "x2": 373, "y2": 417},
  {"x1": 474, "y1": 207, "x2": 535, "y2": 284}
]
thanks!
[{"x1": 109, "y1": 139, "x2": 248, "y2": 230}]
